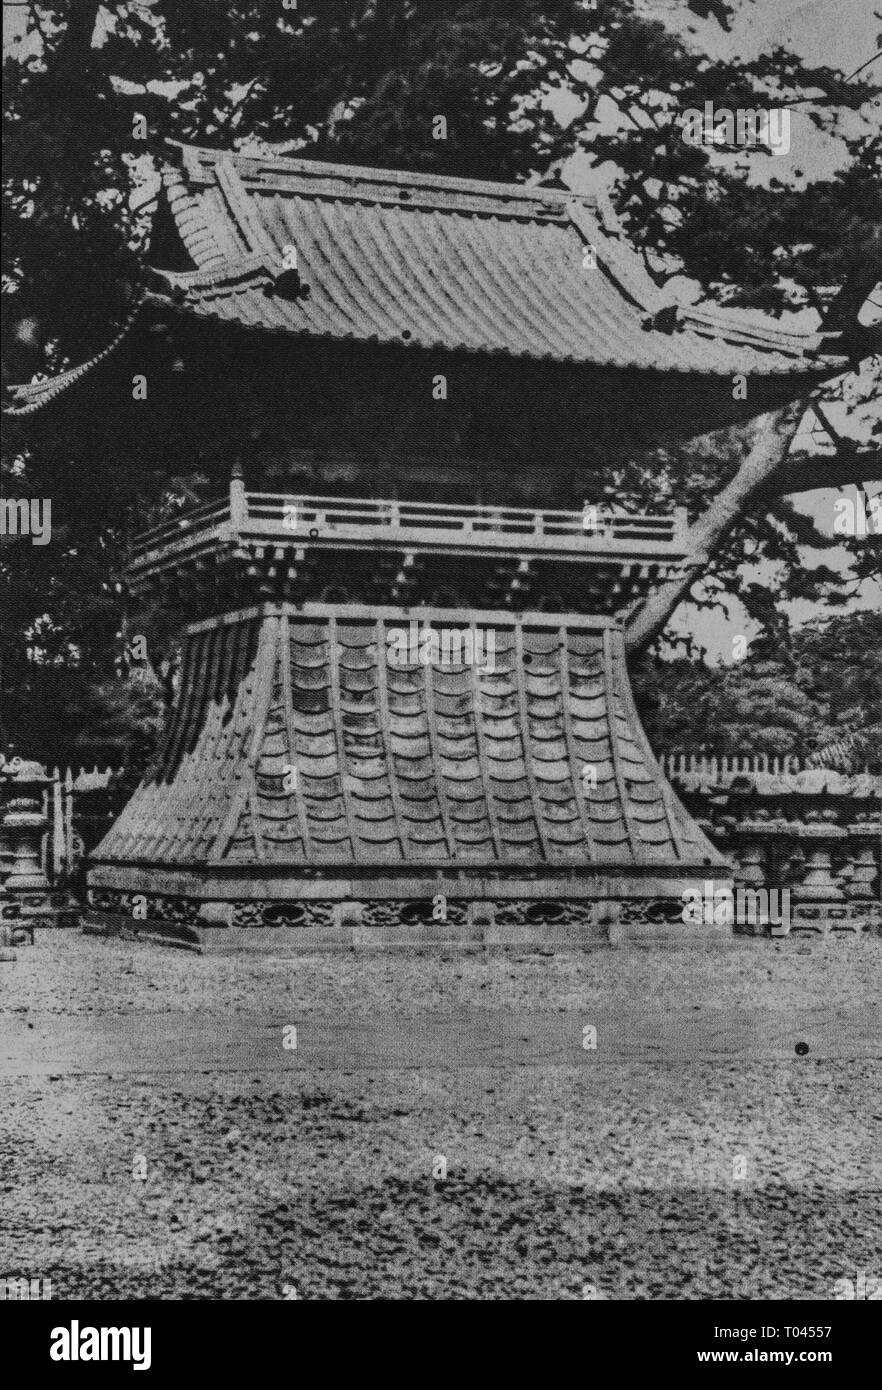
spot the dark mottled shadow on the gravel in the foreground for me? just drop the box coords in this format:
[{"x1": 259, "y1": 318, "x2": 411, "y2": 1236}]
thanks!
[{"x1": 29, "y1": 1175, "x2": 881, "y2": 1300}]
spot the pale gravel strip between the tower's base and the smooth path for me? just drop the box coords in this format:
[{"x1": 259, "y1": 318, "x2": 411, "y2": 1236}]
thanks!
[{"x1": 0, "y1": 931, "x2": 882, "y2": 1017}]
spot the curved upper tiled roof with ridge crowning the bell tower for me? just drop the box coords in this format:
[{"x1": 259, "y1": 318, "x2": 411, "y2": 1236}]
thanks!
[{"x1": 146, "y1": 146, "x2": 844, "y2": 375}]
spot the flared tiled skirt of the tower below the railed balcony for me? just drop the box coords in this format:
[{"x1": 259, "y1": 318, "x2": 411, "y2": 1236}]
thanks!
[{"x1": 93, "y1": 606, "x2": 721, "y2": 872}]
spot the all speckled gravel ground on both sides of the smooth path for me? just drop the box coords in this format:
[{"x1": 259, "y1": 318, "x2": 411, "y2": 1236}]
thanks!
[{"x1": 0, "y1": 933, "x2": 882, "y2": 1298}]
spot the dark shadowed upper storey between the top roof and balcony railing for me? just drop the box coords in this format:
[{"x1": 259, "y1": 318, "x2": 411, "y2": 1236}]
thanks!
[{"x1": 22, "y1": 307, "x2": 822, "y2": 507}]
